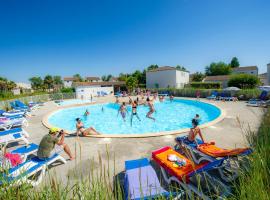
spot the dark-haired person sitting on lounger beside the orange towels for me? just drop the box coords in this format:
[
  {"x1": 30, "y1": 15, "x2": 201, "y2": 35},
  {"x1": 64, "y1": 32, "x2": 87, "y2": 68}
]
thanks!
[{"x1": 175, "y1": 119, "x2": 204, "y2": 146}]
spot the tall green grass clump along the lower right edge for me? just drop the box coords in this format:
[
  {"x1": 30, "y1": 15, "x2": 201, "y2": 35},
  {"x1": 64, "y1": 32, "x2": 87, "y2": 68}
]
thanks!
[{"x1": 231, "y1": 109, "x2": 270, "y2": 200}]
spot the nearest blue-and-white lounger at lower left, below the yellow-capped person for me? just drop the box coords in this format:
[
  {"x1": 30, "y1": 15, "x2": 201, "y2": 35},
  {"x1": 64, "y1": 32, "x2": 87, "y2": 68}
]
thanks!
[{"x1": 0, "y1": 154, "x2": 66, "y2": 186}]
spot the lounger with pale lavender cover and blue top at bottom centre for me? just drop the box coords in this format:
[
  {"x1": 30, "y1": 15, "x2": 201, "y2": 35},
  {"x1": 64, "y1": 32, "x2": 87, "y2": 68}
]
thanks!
[{"x1": 124, "y1": 158, "x2": 182, "y2": 200}]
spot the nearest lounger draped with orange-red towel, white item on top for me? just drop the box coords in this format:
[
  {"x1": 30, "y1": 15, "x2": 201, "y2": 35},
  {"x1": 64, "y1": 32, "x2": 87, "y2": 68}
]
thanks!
[{"x1": 152, "y1": 147, "x2": 230, "y2": 200}]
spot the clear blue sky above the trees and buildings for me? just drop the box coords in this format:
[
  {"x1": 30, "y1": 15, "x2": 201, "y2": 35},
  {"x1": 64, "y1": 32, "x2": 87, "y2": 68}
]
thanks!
[{"x1": 0, "y1": 0, "x2": 270, "y2": 81}]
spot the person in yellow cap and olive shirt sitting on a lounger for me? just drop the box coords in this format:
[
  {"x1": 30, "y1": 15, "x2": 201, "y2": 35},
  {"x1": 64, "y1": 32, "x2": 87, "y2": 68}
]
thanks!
[{"x1": 37, "y1": 127, "x2": 75, "y2": 160}]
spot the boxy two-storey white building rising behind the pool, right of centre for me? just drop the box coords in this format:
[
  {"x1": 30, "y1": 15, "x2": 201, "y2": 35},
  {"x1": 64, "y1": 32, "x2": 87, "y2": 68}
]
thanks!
[{"x1": 146, "y1": 66, "x2": 189, "y2": 88}]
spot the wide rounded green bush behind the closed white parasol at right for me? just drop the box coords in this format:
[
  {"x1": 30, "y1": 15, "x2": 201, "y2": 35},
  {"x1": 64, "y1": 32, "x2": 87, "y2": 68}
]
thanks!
[{"x1": 228, "y1": 74, "x2": 260, "y2": 89}]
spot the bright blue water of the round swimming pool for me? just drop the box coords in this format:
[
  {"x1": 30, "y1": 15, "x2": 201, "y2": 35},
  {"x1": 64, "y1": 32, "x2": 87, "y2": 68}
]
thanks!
[{"x1": 49, "y1": 99, "x2": 221, "y2": 134}]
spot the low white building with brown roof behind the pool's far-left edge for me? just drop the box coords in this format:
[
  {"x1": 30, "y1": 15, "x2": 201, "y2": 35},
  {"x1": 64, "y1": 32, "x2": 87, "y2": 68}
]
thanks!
[{"x1": 74, "y1": 81, "x2": 125, "y2": 99}]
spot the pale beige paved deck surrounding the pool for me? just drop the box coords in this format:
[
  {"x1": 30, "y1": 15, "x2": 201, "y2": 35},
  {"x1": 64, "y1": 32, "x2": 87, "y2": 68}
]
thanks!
[{"x1": 25, "y1": 97, "x2": 263, "y2": 184}]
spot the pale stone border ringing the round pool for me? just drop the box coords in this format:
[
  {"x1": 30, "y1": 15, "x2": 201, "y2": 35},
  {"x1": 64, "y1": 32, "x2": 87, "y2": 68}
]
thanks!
[{"x1": 42, "y1": 97, "x2": 226, "y2": 138}]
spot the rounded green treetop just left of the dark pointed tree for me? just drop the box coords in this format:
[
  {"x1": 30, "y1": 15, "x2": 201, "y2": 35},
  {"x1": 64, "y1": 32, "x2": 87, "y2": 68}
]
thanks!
[{"x1": 205, "y1": 62, "x2": 232, "y2": 76}]
